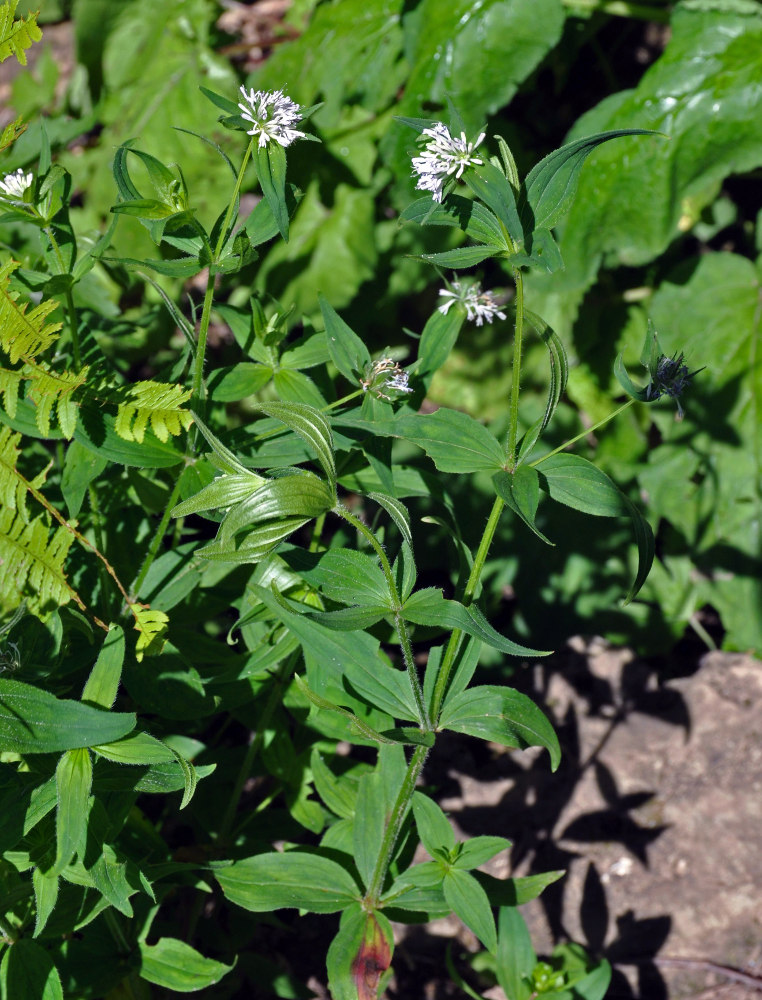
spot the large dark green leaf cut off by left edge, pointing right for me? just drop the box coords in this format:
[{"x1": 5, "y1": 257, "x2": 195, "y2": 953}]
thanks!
[{"x1": 0, "y1": 677, "x2": 135, "y2": 753}]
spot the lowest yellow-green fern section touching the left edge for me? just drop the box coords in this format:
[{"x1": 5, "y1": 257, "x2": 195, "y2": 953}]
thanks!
[{"x1": 0, "y1": 507, "x2": 85, "y2": 616}]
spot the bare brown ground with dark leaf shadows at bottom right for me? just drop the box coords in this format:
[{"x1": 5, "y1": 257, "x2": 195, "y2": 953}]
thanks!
[{"x1": 389, "y1": 641, "x2": 762, "y2": 1000}]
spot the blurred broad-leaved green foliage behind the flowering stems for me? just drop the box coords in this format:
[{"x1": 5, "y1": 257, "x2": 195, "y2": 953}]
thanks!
[{"x1": 8, "y1": 0, "x2": 762, "y2": 651}]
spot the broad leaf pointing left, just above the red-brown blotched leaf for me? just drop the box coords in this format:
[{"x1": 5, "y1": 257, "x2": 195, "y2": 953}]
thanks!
[{"x1": 215, "y1": 851, "x2": 360, "y2": 913}]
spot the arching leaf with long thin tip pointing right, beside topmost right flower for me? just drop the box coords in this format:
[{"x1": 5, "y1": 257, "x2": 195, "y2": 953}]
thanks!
[{"x1": 519, "y1": 128, "x2": 657, "y2": 232}]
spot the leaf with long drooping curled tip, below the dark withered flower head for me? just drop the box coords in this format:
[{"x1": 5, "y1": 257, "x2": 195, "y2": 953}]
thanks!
[{"x1": 540, "y1": 453, "x2": 654, "y2": 601}]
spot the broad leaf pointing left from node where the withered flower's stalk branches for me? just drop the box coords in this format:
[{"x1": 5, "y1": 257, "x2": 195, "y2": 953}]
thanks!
[{"x1": 394, "y1": 407, "x2": 505, "y2": 472}]
